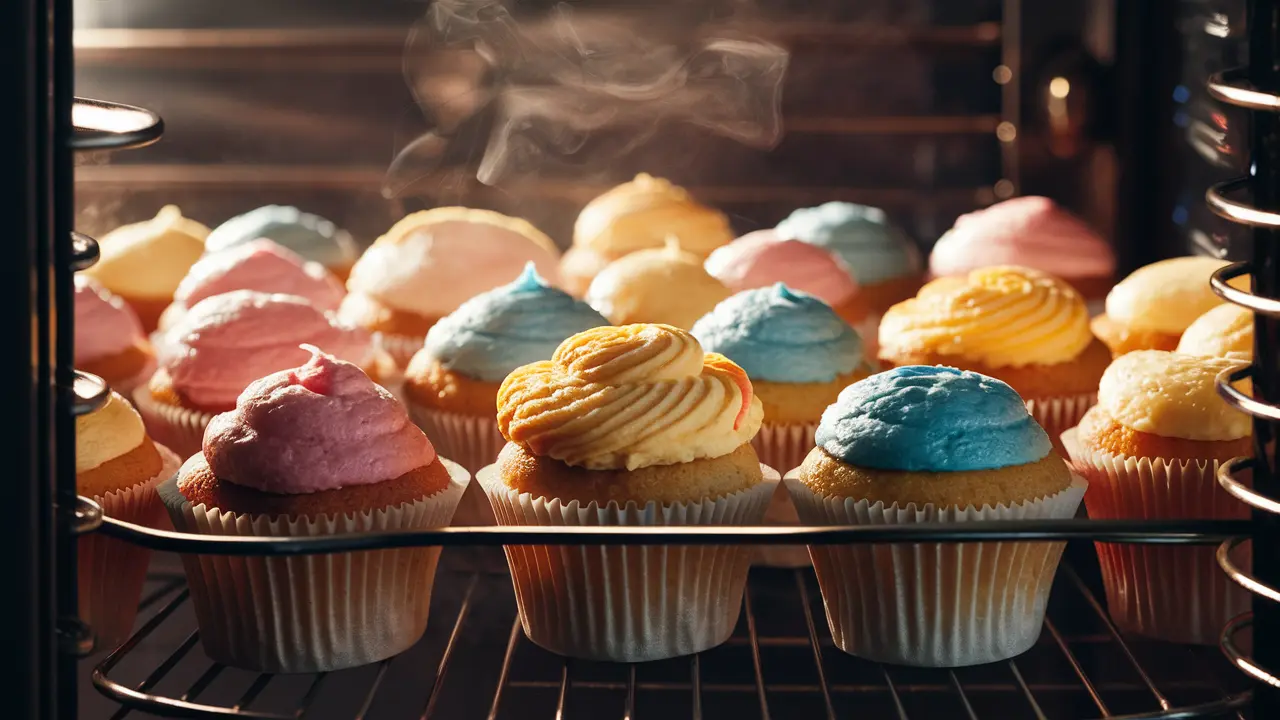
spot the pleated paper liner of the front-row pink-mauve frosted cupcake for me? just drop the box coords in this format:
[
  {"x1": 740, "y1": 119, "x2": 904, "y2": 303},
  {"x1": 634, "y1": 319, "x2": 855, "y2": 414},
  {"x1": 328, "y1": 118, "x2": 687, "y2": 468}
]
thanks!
[{"x1": 160, "y1": 457, "x2": 470, "y2": 673}]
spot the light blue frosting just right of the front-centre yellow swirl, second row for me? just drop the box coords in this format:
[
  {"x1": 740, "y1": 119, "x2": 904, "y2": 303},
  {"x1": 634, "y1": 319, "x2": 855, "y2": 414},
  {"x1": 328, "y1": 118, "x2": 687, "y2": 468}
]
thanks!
[{"x1": 692, "y1": 283, "x2": 863, "y2": 383}]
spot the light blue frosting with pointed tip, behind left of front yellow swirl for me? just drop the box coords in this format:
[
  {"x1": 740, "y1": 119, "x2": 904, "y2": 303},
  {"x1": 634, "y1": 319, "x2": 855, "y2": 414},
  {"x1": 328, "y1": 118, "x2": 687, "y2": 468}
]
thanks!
[{"x1": 426, "y1": 263, "x2": 609, "y2": 383}]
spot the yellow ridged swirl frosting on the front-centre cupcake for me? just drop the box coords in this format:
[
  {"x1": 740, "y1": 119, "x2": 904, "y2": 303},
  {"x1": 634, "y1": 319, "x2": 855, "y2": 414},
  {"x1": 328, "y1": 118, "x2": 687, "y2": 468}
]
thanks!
[{"x1": 498, "y1": 324, "x2": 764, "y2": 470}]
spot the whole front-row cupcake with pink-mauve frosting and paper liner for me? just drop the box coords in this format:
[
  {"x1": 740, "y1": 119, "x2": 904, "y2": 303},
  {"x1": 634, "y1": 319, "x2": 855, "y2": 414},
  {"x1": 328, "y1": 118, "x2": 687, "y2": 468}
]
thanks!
[{"x1": 160, "y1": 346, "x2": 468, "y2": 673}]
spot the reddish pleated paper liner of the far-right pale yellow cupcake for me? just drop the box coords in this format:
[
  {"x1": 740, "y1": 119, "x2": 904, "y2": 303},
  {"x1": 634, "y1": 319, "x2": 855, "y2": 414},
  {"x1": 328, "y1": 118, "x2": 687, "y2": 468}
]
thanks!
[{"x1": 1065, "y1": 432, "x2": 1251, "y2": 644}]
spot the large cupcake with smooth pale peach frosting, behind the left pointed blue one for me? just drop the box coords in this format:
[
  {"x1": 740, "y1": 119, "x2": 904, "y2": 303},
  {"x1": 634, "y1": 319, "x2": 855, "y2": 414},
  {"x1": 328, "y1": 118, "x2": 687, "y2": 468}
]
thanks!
[{"x1": 338, "y1": 208, "x2": 558, "y2": 366}]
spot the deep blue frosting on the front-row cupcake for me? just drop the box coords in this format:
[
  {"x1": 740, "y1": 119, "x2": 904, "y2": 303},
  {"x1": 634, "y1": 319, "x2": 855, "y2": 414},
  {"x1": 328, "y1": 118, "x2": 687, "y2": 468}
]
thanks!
[{"x1": 814, "y1": 365, "x2": 1052, "y2": 473}]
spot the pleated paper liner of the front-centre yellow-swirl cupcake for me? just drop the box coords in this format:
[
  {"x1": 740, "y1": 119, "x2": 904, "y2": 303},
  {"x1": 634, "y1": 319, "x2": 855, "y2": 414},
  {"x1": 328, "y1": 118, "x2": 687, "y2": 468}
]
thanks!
[{"x1": 476, "y1": 465, "x2": 778, "y2": 662}]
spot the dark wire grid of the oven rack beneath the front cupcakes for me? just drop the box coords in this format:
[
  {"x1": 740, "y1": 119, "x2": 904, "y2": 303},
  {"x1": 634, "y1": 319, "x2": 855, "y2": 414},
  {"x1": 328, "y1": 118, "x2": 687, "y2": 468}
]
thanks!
[{"x1": 91, "y1": 551, "x2": 1251, "y2": 720}]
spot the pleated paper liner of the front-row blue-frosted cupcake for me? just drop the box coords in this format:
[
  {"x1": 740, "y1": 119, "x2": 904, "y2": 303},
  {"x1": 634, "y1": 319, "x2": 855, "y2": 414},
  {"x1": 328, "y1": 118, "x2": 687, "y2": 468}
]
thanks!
[{"x1": 783, "y1": 471, "x2": 1087, "y2": 667}]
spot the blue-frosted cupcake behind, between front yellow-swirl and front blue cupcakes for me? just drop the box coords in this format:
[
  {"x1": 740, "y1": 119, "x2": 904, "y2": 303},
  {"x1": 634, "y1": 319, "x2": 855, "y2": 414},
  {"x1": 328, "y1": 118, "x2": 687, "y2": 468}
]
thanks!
[{"x1": 692, "y1": 283, "x2": 869, "y2": 568}]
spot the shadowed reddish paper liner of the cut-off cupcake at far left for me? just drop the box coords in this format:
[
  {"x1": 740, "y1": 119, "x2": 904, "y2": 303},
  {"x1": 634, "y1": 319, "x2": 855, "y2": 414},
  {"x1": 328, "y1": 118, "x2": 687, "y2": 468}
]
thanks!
[{"x1": 76, "y1": 443, "x2": 182, "y2": 651}]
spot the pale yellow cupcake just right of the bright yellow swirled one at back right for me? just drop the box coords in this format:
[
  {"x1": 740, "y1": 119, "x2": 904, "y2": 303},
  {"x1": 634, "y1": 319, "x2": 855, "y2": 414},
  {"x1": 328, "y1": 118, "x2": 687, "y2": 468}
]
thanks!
[{"x1": 1093, "y1": 258, "x2": 1248, "y2": 356}]
